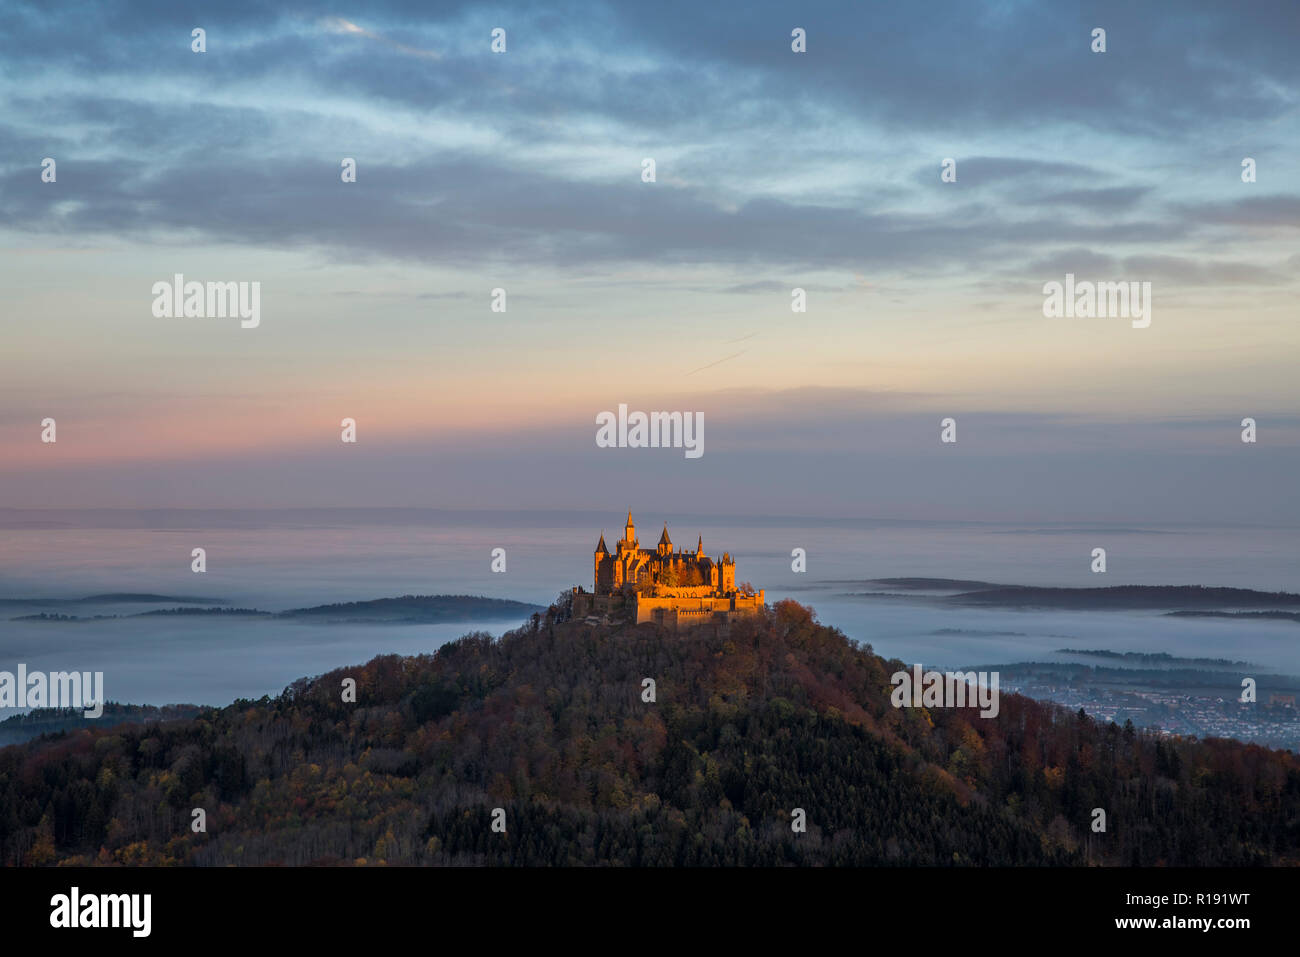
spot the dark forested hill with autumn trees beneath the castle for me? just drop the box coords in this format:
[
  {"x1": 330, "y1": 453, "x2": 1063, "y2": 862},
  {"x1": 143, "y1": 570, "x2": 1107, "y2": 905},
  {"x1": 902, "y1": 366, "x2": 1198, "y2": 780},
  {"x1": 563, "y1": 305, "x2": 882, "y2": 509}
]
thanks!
[{"x1": 0, "y1": 602, "x2": 1300, "y2": 865}]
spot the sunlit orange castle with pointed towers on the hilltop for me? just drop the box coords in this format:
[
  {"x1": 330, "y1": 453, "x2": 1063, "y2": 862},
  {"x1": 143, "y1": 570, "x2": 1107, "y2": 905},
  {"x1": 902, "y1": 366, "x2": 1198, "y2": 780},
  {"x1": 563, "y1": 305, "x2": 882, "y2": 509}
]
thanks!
[{"x1": 573, "y1": 508, "x2": 763, "y2": 627}]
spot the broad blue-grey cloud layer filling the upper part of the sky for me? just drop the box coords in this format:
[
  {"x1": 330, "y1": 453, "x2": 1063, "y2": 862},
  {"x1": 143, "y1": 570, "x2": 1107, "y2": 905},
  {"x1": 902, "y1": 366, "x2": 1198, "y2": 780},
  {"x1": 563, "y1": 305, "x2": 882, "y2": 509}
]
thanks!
[{"x1": 0, "y1": 0, "x2": 1300, "y2": 295}]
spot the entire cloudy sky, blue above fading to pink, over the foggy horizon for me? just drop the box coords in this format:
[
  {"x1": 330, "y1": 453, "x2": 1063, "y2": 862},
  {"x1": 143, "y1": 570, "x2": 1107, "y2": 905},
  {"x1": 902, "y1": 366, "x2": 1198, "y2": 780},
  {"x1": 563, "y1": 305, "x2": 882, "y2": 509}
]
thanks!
[{"x1": 0, "y1": 0, "x2": 1300, "y2": 525}]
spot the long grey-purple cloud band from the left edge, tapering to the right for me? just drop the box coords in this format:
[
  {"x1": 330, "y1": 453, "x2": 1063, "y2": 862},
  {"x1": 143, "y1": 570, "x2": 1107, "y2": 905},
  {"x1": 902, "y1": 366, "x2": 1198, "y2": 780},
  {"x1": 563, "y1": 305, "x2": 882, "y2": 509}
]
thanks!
[{"x1": 0, "y1": 149, "x2": 1186, "y2": 276}]
